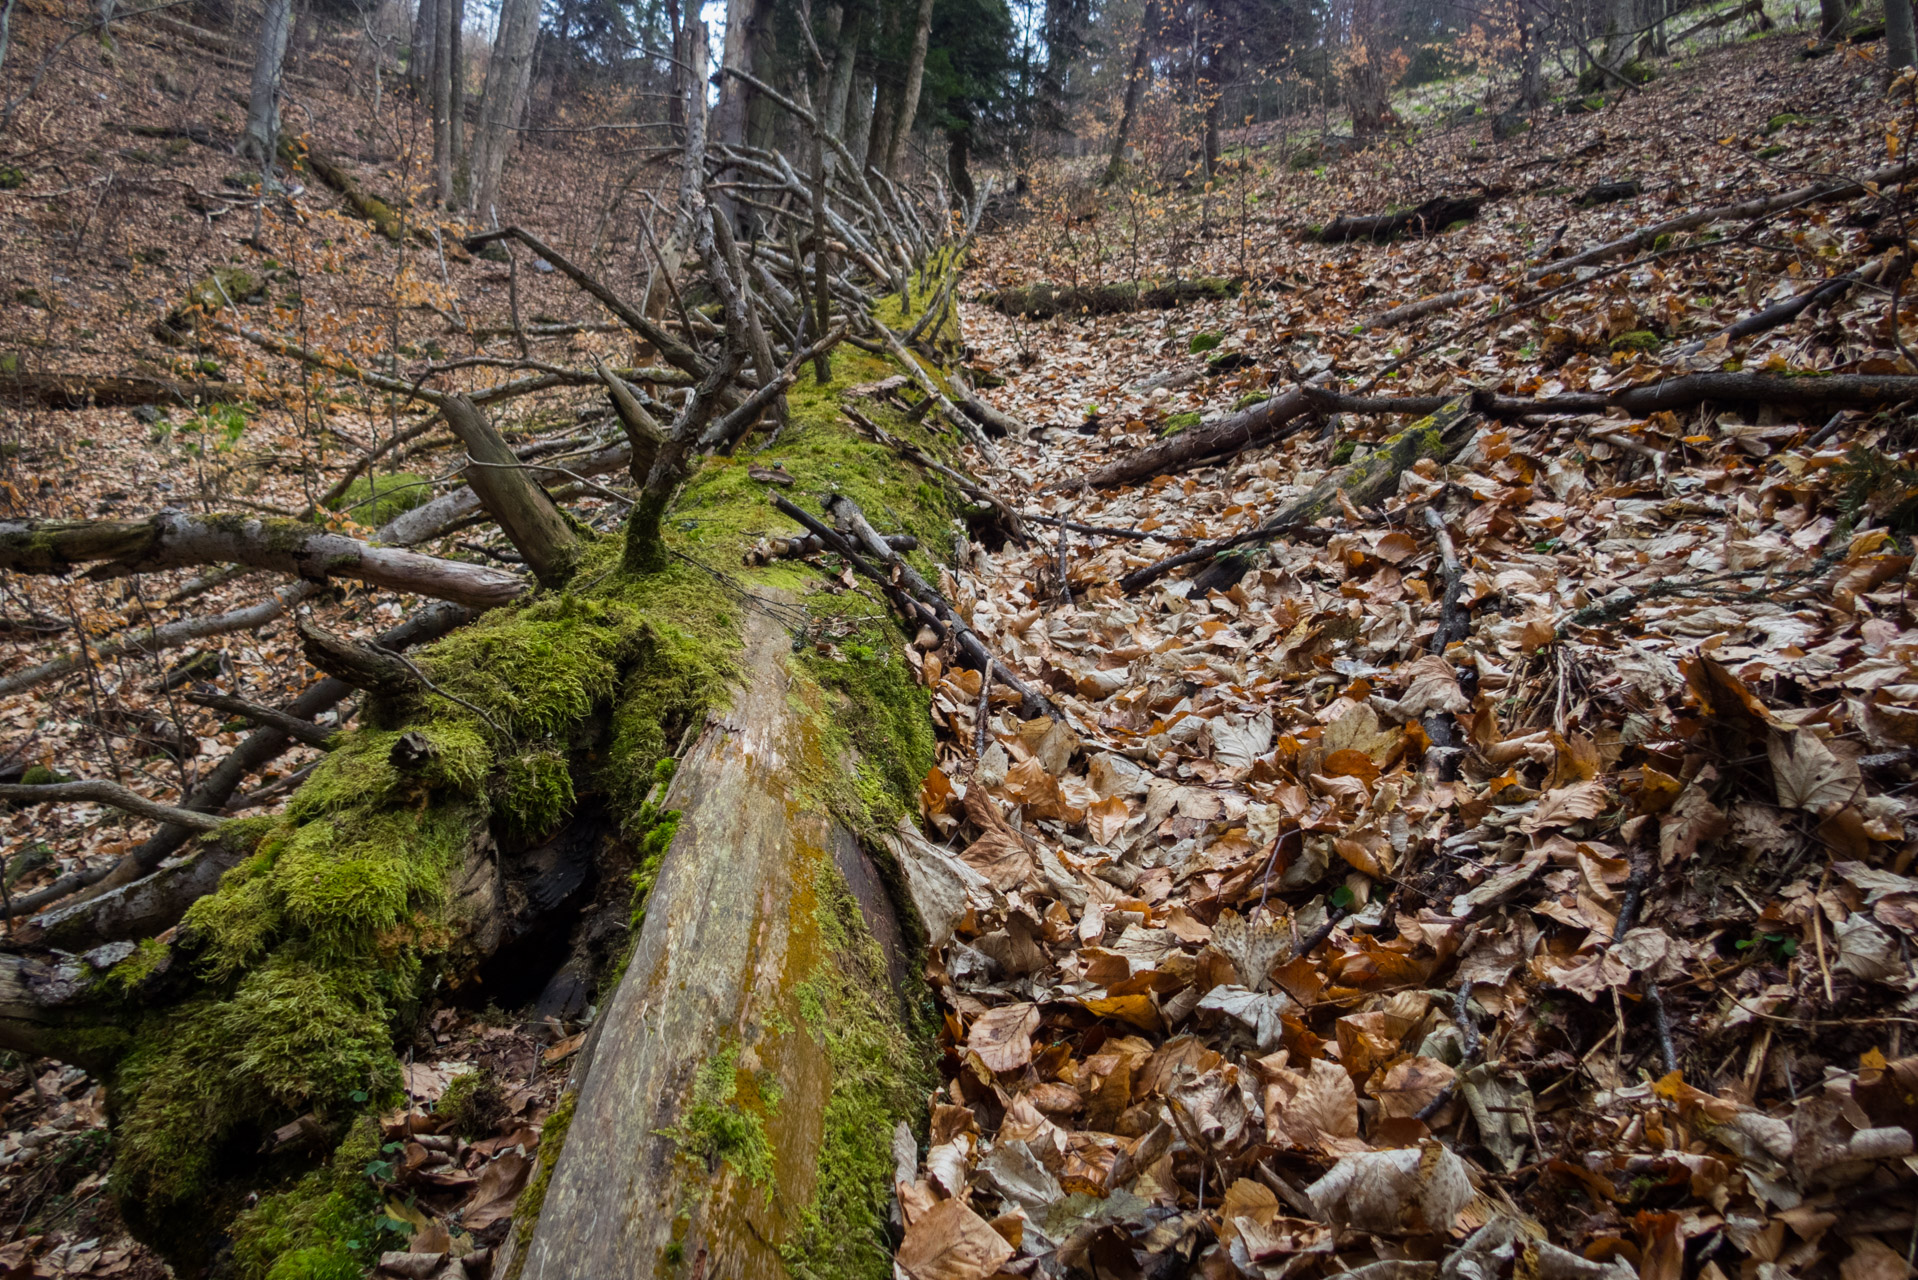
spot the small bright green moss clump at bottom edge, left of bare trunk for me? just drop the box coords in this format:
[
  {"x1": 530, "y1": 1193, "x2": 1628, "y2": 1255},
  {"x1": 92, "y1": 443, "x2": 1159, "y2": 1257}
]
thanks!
[{"x1": 232, "y1": 1117, "x2": 405, "y2": 1280}]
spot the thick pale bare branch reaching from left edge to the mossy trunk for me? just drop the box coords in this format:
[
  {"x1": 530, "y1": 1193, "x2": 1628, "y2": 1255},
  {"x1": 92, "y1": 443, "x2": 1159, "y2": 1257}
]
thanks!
[{"x1": 0, "y1": 510, "x2": 526, "y2": 608}]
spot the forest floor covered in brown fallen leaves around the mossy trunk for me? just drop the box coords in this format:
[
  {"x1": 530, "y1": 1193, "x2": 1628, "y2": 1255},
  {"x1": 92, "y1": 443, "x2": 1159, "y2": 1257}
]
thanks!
[{"x1": 0, "y1": 6, "x2": 1918, "y2": 1280}]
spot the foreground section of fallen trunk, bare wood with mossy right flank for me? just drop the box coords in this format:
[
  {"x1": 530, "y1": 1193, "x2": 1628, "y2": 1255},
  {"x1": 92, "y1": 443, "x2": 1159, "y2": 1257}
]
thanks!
[{"x1": 497, "y1": 614, "x2": 928, "y2": 1280}]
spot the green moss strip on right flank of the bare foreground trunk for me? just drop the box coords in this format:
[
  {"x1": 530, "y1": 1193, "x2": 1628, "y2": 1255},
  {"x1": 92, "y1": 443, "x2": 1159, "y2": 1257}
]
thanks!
[{"x1": 781, "y1": 862, "x2": 938, "y2": 1280}]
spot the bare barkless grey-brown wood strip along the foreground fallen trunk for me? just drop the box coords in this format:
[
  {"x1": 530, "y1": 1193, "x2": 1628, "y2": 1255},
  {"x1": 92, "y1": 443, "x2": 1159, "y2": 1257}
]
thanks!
[{"x1": 518, "y1": 612, "x2": 928, "y2": 1280}]
